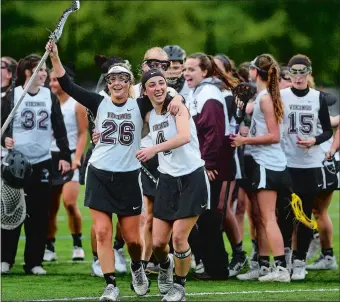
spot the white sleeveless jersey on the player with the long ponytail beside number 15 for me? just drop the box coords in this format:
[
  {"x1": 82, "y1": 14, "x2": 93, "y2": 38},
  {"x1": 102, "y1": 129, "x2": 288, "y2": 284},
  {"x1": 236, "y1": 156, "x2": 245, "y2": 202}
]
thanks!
[{"x1": 249, "y1": 89, "x2": 287, "y2": 171}]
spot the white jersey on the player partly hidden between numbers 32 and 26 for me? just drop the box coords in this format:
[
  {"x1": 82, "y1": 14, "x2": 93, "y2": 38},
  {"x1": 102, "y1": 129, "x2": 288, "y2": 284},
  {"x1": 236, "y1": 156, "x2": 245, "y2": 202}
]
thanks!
[{"x1": 51, "y1": 97, "x2": 78, "y2": 152}]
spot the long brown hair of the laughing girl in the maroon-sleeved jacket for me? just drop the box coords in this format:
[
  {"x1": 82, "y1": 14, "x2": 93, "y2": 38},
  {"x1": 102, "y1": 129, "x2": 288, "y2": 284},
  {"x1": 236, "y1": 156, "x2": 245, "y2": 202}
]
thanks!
[{"x1": 187, "y1": 52, "x2": 239, "y2": 89}]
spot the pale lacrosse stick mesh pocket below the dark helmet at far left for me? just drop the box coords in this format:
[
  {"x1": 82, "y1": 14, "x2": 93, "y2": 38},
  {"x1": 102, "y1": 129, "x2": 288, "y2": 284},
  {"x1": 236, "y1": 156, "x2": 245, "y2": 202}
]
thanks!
[{"x1": 1, "y1": 180, "x2": 26, "y2": 230}]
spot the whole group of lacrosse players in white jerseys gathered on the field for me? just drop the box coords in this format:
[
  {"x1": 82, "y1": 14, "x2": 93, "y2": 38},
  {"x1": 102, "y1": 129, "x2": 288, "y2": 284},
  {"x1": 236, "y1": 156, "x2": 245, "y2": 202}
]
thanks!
[{"x1": 1, "y1": 42, "x2": 340, "y2": 301}]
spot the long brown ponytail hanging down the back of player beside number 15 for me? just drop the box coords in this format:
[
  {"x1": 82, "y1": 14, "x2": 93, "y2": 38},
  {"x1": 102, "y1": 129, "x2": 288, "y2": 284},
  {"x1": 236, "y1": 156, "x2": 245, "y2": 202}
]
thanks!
[{"x1": 254, "y1": 54, "x2": 283, "y2": 123}]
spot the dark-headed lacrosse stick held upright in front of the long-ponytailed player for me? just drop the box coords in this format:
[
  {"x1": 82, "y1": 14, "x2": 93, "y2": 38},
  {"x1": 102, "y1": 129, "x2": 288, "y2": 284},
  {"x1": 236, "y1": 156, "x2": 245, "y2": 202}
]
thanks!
[{"x1": 220, "y1": 82, "x2": 256, "y2": 231}]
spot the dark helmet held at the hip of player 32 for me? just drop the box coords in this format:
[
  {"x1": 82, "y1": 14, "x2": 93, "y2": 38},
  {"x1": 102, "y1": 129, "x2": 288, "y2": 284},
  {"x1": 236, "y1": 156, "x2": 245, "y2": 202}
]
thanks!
[{"x1": 1, "y1": 150, "x2": 32, "y2": 189}]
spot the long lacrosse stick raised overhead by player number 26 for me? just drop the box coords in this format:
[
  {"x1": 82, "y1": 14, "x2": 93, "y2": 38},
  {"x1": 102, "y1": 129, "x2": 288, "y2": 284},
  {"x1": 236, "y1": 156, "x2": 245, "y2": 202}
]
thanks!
[{"x1": 1, "y1": 0, "x2": 80, "y2": 136}]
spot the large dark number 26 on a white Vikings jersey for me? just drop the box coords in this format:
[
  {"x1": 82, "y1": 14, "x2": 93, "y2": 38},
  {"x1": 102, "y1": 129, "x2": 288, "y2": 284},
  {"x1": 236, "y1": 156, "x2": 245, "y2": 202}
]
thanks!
[{"x1": 100, "y1": 120, "x2": 135, "y2": 146}]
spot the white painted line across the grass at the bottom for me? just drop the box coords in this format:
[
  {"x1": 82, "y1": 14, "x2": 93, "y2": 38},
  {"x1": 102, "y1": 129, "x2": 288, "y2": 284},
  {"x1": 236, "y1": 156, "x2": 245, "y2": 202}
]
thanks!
[{"x1": 23, "y1": 288, "x2": 340, "y2": 302}]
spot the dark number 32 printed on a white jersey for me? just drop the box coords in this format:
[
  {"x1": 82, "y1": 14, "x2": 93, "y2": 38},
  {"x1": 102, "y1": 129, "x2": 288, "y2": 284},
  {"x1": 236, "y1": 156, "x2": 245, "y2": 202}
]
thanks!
[{"x1": 21, "y1": 109, "x2": 49, "y2": 130}]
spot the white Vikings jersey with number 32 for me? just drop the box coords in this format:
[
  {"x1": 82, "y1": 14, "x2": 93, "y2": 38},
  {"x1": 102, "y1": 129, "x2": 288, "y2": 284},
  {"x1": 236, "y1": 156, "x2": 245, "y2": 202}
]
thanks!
[{"x1": 13, "y1": 86, "x2": 52, "y2": 164}]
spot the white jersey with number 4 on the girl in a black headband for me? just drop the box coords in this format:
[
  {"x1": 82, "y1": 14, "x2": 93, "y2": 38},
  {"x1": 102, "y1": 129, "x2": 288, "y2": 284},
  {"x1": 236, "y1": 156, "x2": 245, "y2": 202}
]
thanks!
[{"x1": 149, "y1": 110, "x2": 204, "y2": 177}]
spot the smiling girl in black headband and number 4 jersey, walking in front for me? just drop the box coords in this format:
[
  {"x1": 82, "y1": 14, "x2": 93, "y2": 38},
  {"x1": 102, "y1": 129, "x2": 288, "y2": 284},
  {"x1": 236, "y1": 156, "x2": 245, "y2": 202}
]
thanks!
[{"x1": 137, "y1": 69, "x2": 210, "y2": 301}]
